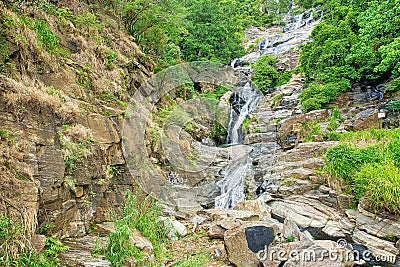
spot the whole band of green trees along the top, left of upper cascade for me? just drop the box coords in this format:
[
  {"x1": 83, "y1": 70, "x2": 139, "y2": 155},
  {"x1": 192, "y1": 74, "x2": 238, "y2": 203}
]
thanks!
[{"x1": 95, "y1": 0, "x2": 290, "y2": 67}]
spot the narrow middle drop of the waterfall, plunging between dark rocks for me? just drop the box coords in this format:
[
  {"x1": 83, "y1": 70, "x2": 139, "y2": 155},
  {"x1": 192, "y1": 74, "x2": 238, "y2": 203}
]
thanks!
[{"x1": 227, "y1": 82, "x2": 263, "y2": 144}]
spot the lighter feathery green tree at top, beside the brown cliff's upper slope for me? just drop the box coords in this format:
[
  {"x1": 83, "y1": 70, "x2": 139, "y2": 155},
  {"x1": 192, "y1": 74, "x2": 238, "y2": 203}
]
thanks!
[{"x1": 104, "y1": 0, "x2": 186, "y2": 65}]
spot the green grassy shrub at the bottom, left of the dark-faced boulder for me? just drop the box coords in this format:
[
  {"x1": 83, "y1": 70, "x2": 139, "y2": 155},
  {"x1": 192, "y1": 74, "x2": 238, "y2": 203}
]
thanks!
[{"x1": 105, "y1": 190, "x2": 169, "y2": 266}]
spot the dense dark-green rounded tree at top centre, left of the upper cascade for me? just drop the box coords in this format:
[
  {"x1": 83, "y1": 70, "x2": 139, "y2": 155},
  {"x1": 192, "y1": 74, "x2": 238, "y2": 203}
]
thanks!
[{"x1": 179, "y1": 0, "x2": 244, "y2": 62}]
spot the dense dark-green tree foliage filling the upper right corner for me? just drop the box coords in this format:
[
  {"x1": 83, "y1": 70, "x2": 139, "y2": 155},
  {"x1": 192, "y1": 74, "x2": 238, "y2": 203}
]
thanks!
[{"x1": 300, "y1": 0, "x2": 400, "y2": 110}]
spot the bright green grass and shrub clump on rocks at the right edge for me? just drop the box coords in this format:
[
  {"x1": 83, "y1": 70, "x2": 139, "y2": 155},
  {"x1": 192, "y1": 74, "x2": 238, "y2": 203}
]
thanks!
[{"x1": 324, "y1": 129, "x2": 400, "y2": 214}]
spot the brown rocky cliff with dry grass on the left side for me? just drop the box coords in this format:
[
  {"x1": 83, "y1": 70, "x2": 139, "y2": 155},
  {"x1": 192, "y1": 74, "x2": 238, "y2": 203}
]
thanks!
[{"x1": 0, "y1": 1, "x2": 152, "y2": 243}]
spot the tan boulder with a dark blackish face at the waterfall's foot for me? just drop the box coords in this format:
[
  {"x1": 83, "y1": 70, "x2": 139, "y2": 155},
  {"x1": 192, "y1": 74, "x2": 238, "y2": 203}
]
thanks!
[{"x1": 224, "y1": 222, "x2": 277, "y2": 267}]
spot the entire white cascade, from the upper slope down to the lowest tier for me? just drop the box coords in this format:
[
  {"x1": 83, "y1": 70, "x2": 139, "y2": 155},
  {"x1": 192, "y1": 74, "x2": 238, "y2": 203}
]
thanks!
[{"x1": 215, "y1": 8, "x2": 318, "y2": 209}]
